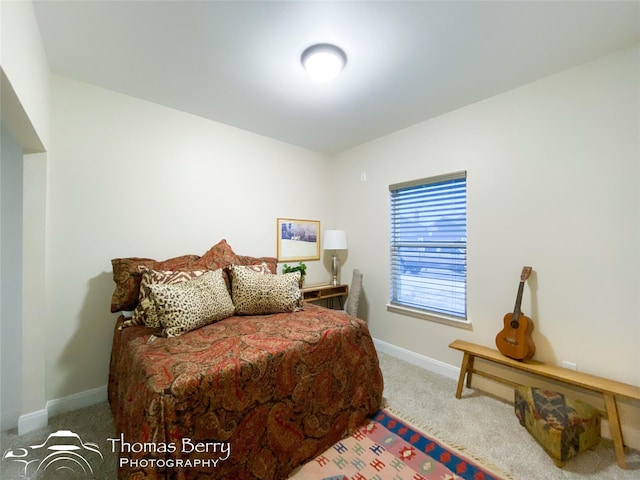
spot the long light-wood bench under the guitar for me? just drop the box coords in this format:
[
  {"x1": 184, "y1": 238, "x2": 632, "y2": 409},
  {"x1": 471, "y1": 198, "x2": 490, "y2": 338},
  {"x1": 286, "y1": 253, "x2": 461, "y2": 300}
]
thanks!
[{"x1": 449, "y1": 340, "x2": 640, "y2": 468}]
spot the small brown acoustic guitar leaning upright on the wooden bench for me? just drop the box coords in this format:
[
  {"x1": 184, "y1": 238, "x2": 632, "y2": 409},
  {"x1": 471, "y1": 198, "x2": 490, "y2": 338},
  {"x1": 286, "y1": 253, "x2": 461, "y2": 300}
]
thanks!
[{"x1": 496, "y1": 267, "x2": 536, "y2": 360}]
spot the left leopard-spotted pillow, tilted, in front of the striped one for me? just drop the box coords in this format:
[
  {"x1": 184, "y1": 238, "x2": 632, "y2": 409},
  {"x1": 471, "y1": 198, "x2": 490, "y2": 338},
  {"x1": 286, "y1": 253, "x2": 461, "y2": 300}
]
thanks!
[{"x1": 149, "y1": 269, "x2": 235, "y2": 337}]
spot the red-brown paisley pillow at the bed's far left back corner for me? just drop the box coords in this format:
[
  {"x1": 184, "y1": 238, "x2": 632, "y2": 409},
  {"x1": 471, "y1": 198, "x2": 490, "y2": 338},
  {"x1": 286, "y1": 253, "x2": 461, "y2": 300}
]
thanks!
[{"x1": 111, "y1": 255, "x2": 200, "y2": 313}]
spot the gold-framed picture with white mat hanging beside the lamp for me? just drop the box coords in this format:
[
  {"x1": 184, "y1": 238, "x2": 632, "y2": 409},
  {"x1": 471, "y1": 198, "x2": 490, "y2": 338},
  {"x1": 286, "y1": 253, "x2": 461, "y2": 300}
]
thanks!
[{"x1": 276, "y1": 218, "x2": 320, "y2": 262}]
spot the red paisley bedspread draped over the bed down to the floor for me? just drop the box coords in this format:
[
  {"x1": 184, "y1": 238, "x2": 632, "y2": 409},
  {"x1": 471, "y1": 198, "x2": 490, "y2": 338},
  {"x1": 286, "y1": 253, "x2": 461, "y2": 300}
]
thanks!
[{"x1": 109, "y1": 304, "x2": 383, "y2": 480}]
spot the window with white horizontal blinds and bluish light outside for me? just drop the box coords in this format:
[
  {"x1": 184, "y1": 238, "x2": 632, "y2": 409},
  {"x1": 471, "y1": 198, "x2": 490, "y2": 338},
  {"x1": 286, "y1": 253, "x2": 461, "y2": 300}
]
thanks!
[{"x1": 389, "y1": 172, "x2": 468, "y2": 323}]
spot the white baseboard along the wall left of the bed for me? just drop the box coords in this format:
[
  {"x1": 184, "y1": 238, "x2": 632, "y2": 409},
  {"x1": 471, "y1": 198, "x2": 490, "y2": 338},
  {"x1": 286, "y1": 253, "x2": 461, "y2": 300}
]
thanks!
[{"x1": 18, "y1": 385, "x2": 107, "y2": 435}]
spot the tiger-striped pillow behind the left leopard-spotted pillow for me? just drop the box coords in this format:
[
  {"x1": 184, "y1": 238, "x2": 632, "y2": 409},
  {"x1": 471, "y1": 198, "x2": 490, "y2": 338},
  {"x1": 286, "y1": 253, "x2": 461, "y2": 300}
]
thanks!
[{"x1": 120, "y1": 266, "x2": 206, "y2": 328}]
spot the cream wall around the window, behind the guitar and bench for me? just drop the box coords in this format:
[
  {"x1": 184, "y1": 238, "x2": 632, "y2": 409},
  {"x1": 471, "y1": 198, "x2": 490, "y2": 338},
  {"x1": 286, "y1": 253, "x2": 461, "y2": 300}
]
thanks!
[{"x1": 333, "y1": 48, "x2": 640, "y2": 444}]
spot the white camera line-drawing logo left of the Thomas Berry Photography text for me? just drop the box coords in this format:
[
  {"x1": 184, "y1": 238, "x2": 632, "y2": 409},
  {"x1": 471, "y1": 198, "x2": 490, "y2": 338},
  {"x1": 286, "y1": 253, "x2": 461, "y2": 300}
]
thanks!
[{"x1": 2, "y1": 430, "x2": 104, "y2": 480}]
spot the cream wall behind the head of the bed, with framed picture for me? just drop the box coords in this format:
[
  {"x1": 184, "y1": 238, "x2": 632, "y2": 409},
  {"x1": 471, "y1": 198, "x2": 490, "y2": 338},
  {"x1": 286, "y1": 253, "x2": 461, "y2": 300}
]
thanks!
[{"x1": 46, "y1": 75, "x2": 332, "y2": 399}]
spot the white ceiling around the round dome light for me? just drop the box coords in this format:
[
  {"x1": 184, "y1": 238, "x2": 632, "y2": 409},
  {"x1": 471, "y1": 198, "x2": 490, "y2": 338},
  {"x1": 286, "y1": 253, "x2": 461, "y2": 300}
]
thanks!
[{"x1": 34, "y1": 0, "x2": 640, "y2": 154}]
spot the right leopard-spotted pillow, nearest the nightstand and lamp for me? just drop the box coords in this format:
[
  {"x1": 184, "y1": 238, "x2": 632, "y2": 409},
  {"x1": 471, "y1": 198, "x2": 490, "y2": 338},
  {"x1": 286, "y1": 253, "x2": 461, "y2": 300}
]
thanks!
[{"x1": 230, "y1": 265, "x2": 302, "y2": 315}]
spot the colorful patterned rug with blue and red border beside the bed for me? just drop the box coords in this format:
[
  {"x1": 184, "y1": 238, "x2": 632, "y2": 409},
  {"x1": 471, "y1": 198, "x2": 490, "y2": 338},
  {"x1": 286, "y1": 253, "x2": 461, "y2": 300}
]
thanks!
[{"x1": 289, "y1": 409, "x2": 508, "y2": 480}]
